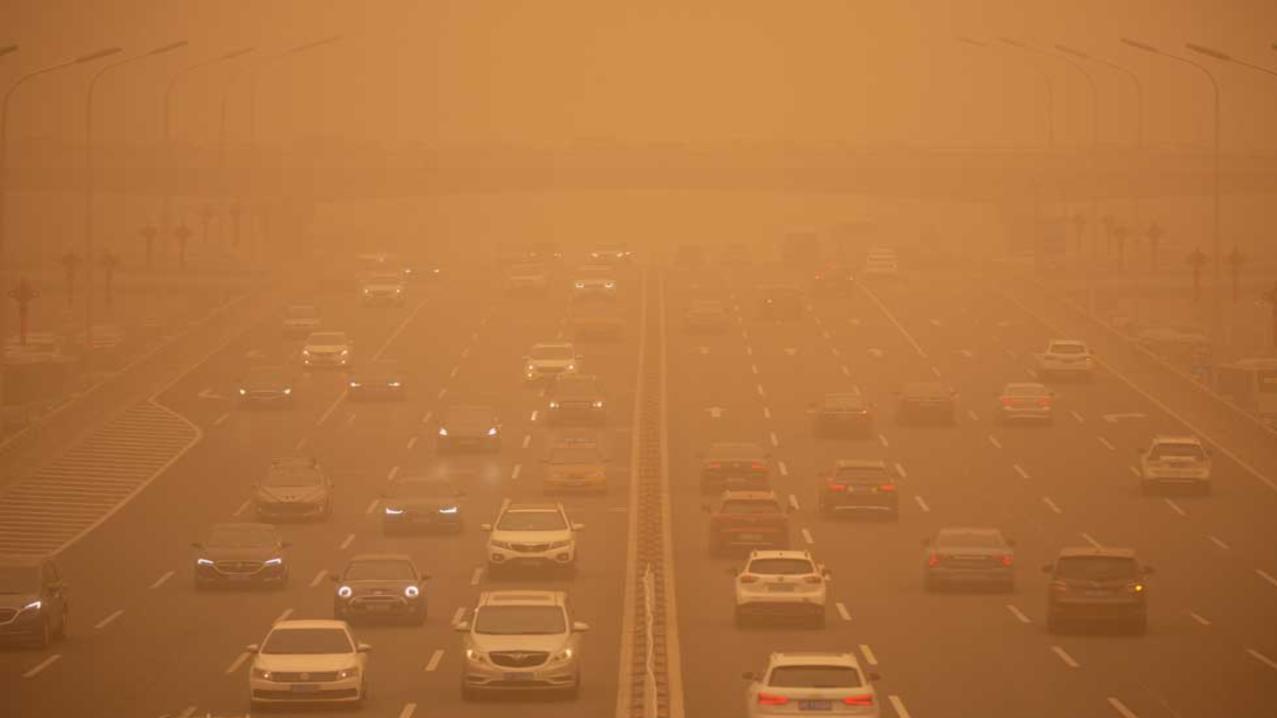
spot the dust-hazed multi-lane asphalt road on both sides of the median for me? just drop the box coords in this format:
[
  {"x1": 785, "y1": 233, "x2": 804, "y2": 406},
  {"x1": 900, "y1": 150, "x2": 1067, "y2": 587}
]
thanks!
[{"x1": 0, "y1": 254, "x2": 1277, "y2": 718}]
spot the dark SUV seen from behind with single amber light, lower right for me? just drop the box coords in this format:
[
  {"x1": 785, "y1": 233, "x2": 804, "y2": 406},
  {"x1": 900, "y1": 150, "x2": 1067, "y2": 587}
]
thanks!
[{"x1": 1042, "y1": 546, "x2": 1153, "y2": 634}]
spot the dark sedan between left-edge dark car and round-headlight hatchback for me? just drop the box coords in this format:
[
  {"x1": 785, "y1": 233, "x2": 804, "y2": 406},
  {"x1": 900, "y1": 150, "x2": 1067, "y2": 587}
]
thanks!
[{"x1": 190, "y1": 523, "x2": 289, "y2": 589}]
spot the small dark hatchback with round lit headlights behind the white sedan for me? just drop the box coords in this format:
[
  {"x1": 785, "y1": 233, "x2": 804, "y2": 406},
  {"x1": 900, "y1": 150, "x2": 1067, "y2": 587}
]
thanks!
[{"x1": 329, "y1": 553, "x2": 430, "y2": 625}]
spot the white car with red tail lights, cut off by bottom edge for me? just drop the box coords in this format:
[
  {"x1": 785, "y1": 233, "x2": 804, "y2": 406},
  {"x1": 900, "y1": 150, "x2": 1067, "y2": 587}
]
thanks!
[{"x1": 743, "y1": 652, "x2": 880, "y2": 718}]
